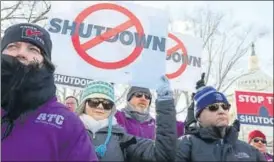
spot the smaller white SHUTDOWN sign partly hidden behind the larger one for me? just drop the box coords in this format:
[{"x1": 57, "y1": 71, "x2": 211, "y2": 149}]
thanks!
[{"x1": 166, "y1": 33, "x2": 203, "y2": 92}]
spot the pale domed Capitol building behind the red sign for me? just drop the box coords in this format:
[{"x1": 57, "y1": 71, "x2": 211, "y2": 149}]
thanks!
[{"x1": 228, "y1": 44, "x2": 273, "y2": 154}]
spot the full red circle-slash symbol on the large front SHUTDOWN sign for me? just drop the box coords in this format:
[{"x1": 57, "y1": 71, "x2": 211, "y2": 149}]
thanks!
[{"x1": 71, "y1": 3, "x2": 144, "y2": 69}]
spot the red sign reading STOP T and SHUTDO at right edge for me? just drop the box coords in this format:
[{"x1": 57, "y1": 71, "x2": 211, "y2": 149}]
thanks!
[{"x1": 235, "y1": 91, "x2": 273, "y2": 126}]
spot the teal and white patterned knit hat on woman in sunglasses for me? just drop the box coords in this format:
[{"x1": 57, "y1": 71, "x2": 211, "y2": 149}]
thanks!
[{"x1": 77, "y1": 81, "x2": 115, "y2": 115}]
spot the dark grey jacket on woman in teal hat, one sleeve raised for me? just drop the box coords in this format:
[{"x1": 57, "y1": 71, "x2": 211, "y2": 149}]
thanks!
[{"x1": 89, "y1": 100, "x2": 177, "y2": 162}]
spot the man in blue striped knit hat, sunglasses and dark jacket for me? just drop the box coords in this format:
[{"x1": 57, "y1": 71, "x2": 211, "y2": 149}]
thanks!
[{"x1": 176, "y1": 86, "x2": 266, "y2": 162}]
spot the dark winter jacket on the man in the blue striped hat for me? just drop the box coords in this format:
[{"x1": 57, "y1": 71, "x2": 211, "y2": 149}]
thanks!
[{"x1": 176, "y1": 126, "x2": 266, "y2": 162}]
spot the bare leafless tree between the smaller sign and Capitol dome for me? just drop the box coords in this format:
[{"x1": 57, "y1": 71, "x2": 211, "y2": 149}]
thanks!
[{"x1": 168, "y1": 7, "x2": 268, "y2": 113}]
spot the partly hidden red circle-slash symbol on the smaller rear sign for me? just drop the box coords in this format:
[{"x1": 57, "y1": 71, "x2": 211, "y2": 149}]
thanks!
[{"x1": 166, "y1": 33, "x2": 188, "y2": 79}]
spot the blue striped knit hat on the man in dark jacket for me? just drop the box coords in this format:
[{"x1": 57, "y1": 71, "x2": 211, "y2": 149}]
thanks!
[{"x1": 194, "y1": 86, "x2": 229, "y2": 118}]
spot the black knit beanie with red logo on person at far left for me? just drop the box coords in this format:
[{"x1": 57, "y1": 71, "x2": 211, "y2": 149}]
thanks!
[{"x1": 1, "y1": 23, "x2": 52, "y2": 60}]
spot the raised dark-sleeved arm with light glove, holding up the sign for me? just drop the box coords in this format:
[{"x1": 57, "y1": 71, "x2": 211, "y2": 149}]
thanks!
[{"x1": 126, "y1": 78, "x2": 177, "y2": 162}]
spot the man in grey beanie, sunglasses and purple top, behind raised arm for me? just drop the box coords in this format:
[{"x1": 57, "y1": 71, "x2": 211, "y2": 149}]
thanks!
[{"x1": 115, "y1": 86, "x2": 184, "y2": 139}]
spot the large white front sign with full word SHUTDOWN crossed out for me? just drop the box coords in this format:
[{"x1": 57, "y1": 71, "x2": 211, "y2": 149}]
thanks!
[{"x1": 46, "y1": 1, "x2": 168, "y2": 88}]
